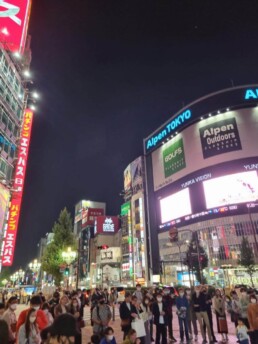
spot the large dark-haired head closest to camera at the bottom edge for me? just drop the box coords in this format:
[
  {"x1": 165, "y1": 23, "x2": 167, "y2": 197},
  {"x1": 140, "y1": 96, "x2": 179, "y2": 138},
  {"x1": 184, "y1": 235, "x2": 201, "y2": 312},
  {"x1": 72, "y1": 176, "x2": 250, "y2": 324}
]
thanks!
[{"x1": 41, "y1": 313, "x2": 81, "y2": 344}]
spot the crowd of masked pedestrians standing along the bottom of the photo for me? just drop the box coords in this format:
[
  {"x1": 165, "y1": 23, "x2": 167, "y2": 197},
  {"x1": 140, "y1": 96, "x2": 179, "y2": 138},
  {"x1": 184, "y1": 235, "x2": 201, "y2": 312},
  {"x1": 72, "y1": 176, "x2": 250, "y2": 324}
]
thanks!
[{"x1": 0, "y1": 285, "x2": 258, "y2": 344}]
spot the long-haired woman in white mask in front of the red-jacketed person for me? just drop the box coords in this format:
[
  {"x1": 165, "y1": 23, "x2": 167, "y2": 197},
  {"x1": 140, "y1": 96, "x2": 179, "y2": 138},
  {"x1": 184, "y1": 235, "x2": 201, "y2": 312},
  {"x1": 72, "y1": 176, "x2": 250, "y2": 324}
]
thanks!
[{"x1": 17, "y1": 308, "x2": 41, "y2": 344}]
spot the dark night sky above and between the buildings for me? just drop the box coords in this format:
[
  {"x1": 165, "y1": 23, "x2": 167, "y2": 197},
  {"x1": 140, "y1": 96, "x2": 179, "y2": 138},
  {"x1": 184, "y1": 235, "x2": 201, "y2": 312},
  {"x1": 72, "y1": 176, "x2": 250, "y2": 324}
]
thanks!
[{"x1": 14, "y1": 0, "x2": 258, "y2": 268}]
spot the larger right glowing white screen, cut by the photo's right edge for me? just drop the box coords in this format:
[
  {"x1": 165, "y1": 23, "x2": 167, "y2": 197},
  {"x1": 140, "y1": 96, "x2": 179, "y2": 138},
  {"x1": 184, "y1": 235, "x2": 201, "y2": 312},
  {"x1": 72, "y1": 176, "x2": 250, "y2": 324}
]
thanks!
[{"x1": 203, "y1": 171, "x2": 258, "y2": 209}]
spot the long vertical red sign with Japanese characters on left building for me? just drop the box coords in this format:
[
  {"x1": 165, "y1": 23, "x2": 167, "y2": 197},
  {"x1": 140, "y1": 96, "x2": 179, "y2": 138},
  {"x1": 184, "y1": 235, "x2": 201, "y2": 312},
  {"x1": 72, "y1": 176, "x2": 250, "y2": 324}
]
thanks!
[{"x1": 2, "y1": 110, "x2": 33, "y2": 266}]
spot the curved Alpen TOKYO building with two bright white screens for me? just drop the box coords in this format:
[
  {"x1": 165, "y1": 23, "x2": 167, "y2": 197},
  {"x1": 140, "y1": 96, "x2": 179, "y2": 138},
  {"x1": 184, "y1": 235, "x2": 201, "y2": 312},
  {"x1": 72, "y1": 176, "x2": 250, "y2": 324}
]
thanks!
[{"x1": 144, "y1": 85, "x2": 258, "y2": 286}]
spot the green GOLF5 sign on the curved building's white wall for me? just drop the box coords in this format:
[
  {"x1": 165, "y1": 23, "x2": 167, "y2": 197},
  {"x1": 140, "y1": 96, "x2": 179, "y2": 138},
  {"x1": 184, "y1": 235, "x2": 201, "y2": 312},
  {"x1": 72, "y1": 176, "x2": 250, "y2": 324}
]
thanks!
[{"x1": 163, "y1": 139, "x2": 186, "y2": 178}]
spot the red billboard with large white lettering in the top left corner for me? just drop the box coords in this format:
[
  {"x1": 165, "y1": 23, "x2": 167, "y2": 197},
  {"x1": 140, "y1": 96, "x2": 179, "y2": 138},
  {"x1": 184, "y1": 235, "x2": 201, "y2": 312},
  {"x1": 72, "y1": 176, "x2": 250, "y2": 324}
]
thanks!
[{"x1": 0, "y1": 0, "x2": 31, "y2": 53}]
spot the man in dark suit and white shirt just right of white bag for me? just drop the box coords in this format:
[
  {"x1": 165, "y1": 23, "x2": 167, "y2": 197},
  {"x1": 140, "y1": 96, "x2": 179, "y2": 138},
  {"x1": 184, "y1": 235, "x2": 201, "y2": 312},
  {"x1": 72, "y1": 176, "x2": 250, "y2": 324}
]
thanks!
[{"x1": 152, "y1": 293, "x2": 168, "y2": 344}]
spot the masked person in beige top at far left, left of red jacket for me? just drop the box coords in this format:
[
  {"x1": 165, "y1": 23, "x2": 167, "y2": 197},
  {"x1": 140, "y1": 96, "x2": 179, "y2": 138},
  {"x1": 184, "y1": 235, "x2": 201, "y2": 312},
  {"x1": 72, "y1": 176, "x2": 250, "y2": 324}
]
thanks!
[{"x1": 2, "y1": 296, "x2": 17, "y2": 344}]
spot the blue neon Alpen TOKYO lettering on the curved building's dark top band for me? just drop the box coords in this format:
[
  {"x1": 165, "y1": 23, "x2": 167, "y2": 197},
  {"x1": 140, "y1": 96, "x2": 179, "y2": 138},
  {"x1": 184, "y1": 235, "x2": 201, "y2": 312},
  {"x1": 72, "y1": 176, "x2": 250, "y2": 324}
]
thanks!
[{"x1": 146, "y1": 109, "x2": 192, "y2": 150}]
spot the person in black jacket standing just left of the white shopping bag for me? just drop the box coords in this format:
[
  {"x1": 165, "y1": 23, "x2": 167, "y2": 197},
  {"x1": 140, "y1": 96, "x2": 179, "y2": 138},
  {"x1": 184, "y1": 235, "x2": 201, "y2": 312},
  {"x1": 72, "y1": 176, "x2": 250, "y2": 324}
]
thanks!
[{"x1": 119, "y1": 292, "x2": 138, "y2": 339}]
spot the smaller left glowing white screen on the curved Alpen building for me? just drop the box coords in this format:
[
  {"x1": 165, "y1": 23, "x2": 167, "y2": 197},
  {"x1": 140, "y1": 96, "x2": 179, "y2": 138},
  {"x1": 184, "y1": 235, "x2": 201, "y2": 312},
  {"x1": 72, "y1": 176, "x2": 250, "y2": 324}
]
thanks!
[{"x1": 160, "y1": 188, "x2": 192, "y2": 223}]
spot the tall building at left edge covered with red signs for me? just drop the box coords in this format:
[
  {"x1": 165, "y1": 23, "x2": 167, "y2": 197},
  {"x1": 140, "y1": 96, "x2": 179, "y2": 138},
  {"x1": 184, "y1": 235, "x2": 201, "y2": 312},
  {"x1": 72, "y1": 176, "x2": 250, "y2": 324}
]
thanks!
[{"x1": 0, "y1": 0, "x2": 32, "y2": 270}]
